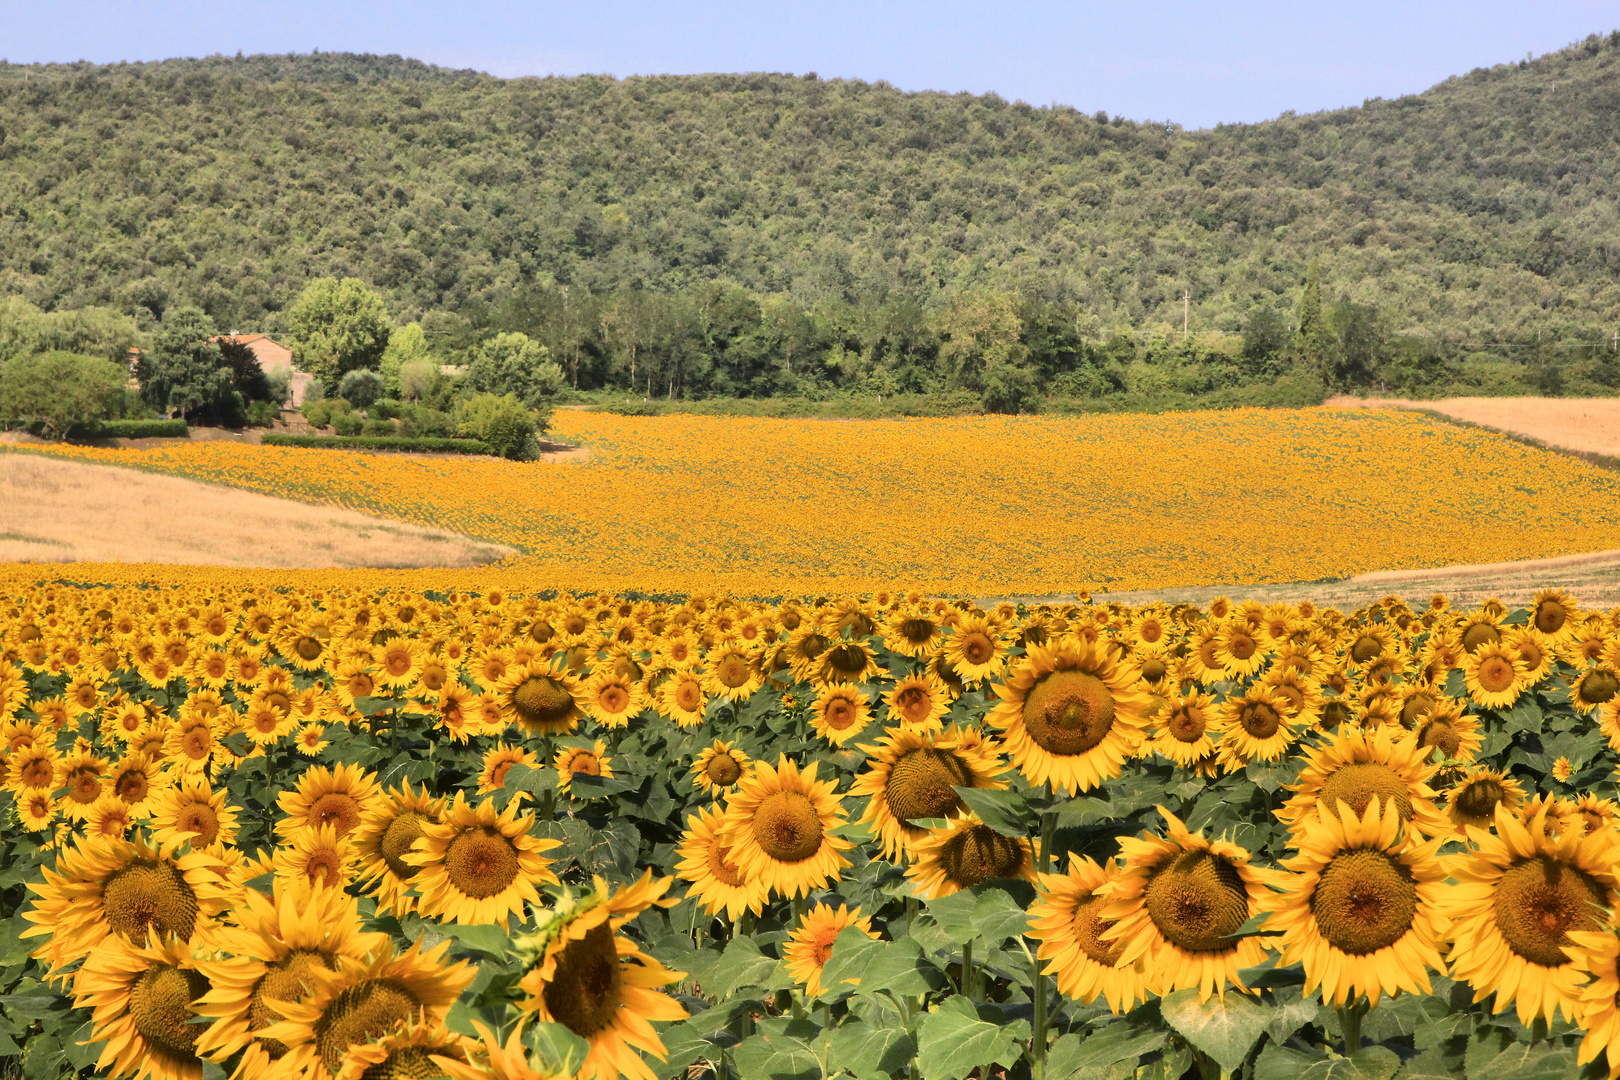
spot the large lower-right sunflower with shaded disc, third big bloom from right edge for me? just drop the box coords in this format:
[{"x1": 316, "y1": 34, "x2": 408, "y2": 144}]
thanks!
[{"x1": 1097, "y1": 806, "x2": 1272, "y2": 1001}]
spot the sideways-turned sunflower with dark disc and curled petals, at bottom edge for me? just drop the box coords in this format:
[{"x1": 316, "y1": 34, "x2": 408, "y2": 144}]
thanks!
[{"x1": 514, "y1": 871, "x2": 687, "y2": 1080}]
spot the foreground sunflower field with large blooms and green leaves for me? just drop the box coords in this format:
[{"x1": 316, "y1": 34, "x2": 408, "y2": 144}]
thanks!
[{"x1": 0, "y1": 581, "x2": 1620, "y2": 1080}]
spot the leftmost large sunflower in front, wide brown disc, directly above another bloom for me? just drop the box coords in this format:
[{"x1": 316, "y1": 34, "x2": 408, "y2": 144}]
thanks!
[{"x1": 21, "y1": 837, "x2": 230, "y2": 975}]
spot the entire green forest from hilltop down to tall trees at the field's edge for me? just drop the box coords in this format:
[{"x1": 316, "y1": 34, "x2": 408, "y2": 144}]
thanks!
[{"x1": 0, "y1": 32, "x2": 1620, "y2": 398}]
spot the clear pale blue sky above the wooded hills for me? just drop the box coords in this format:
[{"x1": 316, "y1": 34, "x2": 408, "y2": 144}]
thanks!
[{"x1": 0, "y1": 0, "x2": 1620, "y2": 128}]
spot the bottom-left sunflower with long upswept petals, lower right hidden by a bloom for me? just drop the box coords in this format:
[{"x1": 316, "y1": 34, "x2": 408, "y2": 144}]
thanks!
[{"x1": 196, "y1": 878, "x2": 390, "y2": 1080}]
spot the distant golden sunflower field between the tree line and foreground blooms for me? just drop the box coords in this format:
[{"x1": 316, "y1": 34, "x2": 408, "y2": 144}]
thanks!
[{"x1": 9, "y1": 410, "x2": 1620, "y2": 597}]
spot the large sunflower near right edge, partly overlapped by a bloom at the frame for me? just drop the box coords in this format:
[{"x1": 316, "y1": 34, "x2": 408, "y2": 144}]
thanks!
[{"x1": 1442, "y1": 805, "x2": 1615, "y2": 1025}]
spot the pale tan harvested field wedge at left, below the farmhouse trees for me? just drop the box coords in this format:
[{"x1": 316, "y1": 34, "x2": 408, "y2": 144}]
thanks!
[{"x1": 0, "y1": 453, "x2": 512, "y2": 568}]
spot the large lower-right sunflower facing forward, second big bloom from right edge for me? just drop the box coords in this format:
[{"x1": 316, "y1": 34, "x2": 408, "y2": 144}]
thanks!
[{"x1": 1264, "y1": 798, "x2": 1445, "y2": 1009}]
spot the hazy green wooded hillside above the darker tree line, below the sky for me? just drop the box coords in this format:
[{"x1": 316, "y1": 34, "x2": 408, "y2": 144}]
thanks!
[{"x1": 0, "y1": 32, "x2": 1620, "y2": 342}]
